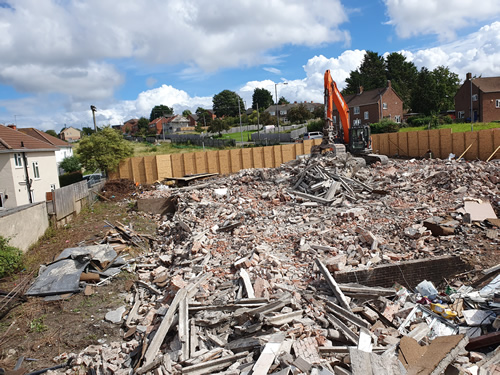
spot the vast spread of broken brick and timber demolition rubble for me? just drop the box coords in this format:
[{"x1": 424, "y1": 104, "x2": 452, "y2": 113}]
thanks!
[{"x1": 7, "y1": 157, "x2": 500, "y2": 375}]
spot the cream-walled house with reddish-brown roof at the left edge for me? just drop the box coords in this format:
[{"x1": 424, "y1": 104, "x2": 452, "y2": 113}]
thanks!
[{"x1": 0, "y1": 125, "x2": 59, "y2": 209}]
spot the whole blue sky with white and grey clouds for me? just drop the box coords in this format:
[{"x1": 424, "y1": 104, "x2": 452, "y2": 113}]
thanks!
[{"x1": 0, "y1": 0, "x2": 500, "y2": 132}]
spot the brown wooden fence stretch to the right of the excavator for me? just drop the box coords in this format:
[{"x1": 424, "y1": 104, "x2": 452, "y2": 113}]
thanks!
[{"x1": 372, "y1": 128, "x2": 500, "y2": 160}]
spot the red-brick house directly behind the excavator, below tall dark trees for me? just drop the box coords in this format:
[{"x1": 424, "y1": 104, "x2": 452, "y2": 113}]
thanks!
[{"x1": 333, "y1": 81, "x2": 403, "y2": 126}]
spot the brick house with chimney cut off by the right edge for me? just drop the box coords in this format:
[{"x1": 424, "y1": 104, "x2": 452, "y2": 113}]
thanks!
[{"x1": 455, "y1": 73, "x2": 500, "y2": 122}]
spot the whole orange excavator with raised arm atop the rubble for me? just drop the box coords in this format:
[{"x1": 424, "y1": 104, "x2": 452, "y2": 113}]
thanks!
[{"x1": 311, "y1": 70, "x2": 388, "y2": 164}]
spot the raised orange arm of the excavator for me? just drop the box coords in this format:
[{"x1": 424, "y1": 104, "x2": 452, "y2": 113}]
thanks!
[{"x1": 325, "y1": 70, "x2": 350, "y2": 145}]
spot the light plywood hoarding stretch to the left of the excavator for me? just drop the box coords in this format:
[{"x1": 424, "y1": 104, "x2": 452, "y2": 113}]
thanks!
[{"x1": 109, "y1": 139, "x2": 321, "y2": 184}]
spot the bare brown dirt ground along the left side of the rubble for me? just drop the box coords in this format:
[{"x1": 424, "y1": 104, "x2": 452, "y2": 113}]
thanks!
[{"x1": 0, "y1": 181, "x2": 156, "y2": 371}]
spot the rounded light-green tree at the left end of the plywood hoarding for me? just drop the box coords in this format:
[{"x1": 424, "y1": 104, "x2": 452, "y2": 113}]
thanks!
[{"x1": 76, "y1": 126, "x2": 134, "y2": 172}]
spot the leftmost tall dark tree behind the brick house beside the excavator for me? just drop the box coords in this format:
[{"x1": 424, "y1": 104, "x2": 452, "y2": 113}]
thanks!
[{"x1": 343, "y1": 51, "x2": 387, "y2": 94}]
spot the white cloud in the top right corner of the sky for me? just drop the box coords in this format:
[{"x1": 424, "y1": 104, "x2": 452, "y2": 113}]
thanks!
[{"x1": 384, "y1": 0, "x2": 500, "y2": 40}]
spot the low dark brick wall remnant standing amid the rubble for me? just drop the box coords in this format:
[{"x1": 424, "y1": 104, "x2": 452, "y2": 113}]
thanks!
[{"x1": 334, "y1": 256, "x2": 470, "y2": 289}]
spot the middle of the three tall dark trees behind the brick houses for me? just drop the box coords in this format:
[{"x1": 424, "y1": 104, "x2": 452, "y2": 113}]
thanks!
[{"x1": 386, "y1": 52, "x2": 418, "y2": 109}]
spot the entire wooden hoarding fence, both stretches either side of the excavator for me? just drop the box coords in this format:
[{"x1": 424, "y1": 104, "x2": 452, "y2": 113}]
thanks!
[{"x1": 110, "y1": 128, "x2": 500, "y2": 184}]
